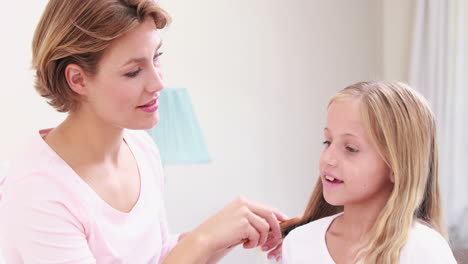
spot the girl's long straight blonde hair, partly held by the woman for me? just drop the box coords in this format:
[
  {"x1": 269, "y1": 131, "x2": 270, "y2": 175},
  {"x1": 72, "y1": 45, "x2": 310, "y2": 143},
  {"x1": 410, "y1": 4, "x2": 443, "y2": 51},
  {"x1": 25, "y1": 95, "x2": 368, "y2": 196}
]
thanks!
[{"x1": 284, "y1": 82, "x2": 447, "y2": 264}]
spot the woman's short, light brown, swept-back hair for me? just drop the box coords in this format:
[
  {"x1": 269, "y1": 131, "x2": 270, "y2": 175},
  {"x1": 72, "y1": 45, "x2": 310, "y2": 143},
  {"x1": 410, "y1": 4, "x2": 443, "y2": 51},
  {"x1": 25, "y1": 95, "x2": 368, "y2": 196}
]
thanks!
[{"x1": 32, "y1": 0, "x2": 170, "y2": 112}]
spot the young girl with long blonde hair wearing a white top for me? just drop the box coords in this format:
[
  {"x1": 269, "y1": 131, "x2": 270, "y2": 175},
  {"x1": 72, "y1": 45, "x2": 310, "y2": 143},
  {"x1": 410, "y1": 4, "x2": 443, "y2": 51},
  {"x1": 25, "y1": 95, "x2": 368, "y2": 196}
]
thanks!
[{"x1": 283, "y1": 82, "x2": 456, "y2": 264}]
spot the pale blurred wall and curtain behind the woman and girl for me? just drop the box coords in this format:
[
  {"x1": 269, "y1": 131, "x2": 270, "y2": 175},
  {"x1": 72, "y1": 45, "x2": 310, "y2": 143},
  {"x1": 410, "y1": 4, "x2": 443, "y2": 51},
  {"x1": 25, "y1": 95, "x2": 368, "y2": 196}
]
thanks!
[{"x1": 0, "y1": 0, "x2": 468, "y2": 264}]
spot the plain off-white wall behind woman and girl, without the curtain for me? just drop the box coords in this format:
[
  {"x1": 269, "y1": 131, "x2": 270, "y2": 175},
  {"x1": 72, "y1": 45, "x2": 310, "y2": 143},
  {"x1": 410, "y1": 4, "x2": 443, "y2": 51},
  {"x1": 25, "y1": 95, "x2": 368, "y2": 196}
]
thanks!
[{"x1": 0, "y1": 0, "x2": 382, "y2": 264}]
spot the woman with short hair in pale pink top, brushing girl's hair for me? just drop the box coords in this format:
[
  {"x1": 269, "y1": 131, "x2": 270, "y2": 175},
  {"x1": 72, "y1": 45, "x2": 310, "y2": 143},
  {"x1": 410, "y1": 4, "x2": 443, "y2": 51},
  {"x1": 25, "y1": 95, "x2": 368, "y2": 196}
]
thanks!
[{"x1": 0, "y1": 0, "x2": 285, "y2": 264}]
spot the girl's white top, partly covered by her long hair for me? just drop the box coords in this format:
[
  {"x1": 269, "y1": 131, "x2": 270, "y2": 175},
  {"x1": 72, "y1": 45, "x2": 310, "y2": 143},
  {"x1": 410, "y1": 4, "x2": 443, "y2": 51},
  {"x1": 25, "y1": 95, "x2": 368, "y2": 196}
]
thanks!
[{"x1": 283, "y1": 213, "x2": 457, "y2": 264}]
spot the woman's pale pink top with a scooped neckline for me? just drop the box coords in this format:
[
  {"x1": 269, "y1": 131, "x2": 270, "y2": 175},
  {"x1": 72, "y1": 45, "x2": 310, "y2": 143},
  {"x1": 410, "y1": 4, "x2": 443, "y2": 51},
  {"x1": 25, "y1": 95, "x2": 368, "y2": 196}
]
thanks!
[{"x1": 0, "y1": 130, "x2": 177, "y2": 264}]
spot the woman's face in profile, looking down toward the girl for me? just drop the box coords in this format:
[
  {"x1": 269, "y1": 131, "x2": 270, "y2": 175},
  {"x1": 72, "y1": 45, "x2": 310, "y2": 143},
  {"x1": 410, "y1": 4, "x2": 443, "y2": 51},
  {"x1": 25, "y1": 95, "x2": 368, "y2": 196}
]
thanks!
[{"x1": 80, "y1": 18, "x2": 163, "y2": 129}]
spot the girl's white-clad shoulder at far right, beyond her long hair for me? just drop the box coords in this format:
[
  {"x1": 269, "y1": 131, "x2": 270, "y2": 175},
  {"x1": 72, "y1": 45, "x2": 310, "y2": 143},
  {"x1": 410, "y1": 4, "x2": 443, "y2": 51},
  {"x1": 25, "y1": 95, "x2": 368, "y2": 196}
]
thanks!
[{"x1": 401, "y1": 221, "x2": 457, "y2": 264}]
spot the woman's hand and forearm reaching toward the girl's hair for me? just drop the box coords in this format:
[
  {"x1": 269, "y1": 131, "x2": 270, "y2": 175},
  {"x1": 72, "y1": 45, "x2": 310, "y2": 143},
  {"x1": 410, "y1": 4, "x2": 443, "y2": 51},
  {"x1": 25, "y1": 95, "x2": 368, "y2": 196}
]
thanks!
[{"x1": 168, "y1": 197, "x2": 286, "y2": 263}]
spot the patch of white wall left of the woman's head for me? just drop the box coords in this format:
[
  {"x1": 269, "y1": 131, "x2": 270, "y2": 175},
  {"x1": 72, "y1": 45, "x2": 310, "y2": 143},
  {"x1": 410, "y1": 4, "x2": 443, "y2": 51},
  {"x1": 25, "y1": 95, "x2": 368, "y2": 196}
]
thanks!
[{"x1": 0, "y1": 0, "x2": 64, "y2": 160}]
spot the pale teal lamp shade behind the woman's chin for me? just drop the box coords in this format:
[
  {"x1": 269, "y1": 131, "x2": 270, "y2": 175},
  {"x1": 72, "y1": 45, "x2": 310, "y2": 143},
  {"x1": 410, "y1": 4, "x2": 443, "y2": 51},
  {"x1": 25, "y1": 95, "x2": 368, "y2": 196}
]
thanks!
[{"x1": 147, "y1": 88, "x2": 211, "y2": 165}]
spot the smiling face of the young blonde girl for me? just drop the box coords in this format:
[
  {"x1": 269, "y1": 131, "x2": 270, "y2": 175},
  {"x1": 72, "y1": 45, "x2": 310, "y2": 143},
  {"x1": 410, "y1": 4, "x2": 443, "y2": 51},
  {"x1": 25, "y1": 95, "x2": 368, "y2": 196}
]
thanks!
[{"x1": 320, "y1": 99, "x2": 393, "y2": 206}]
